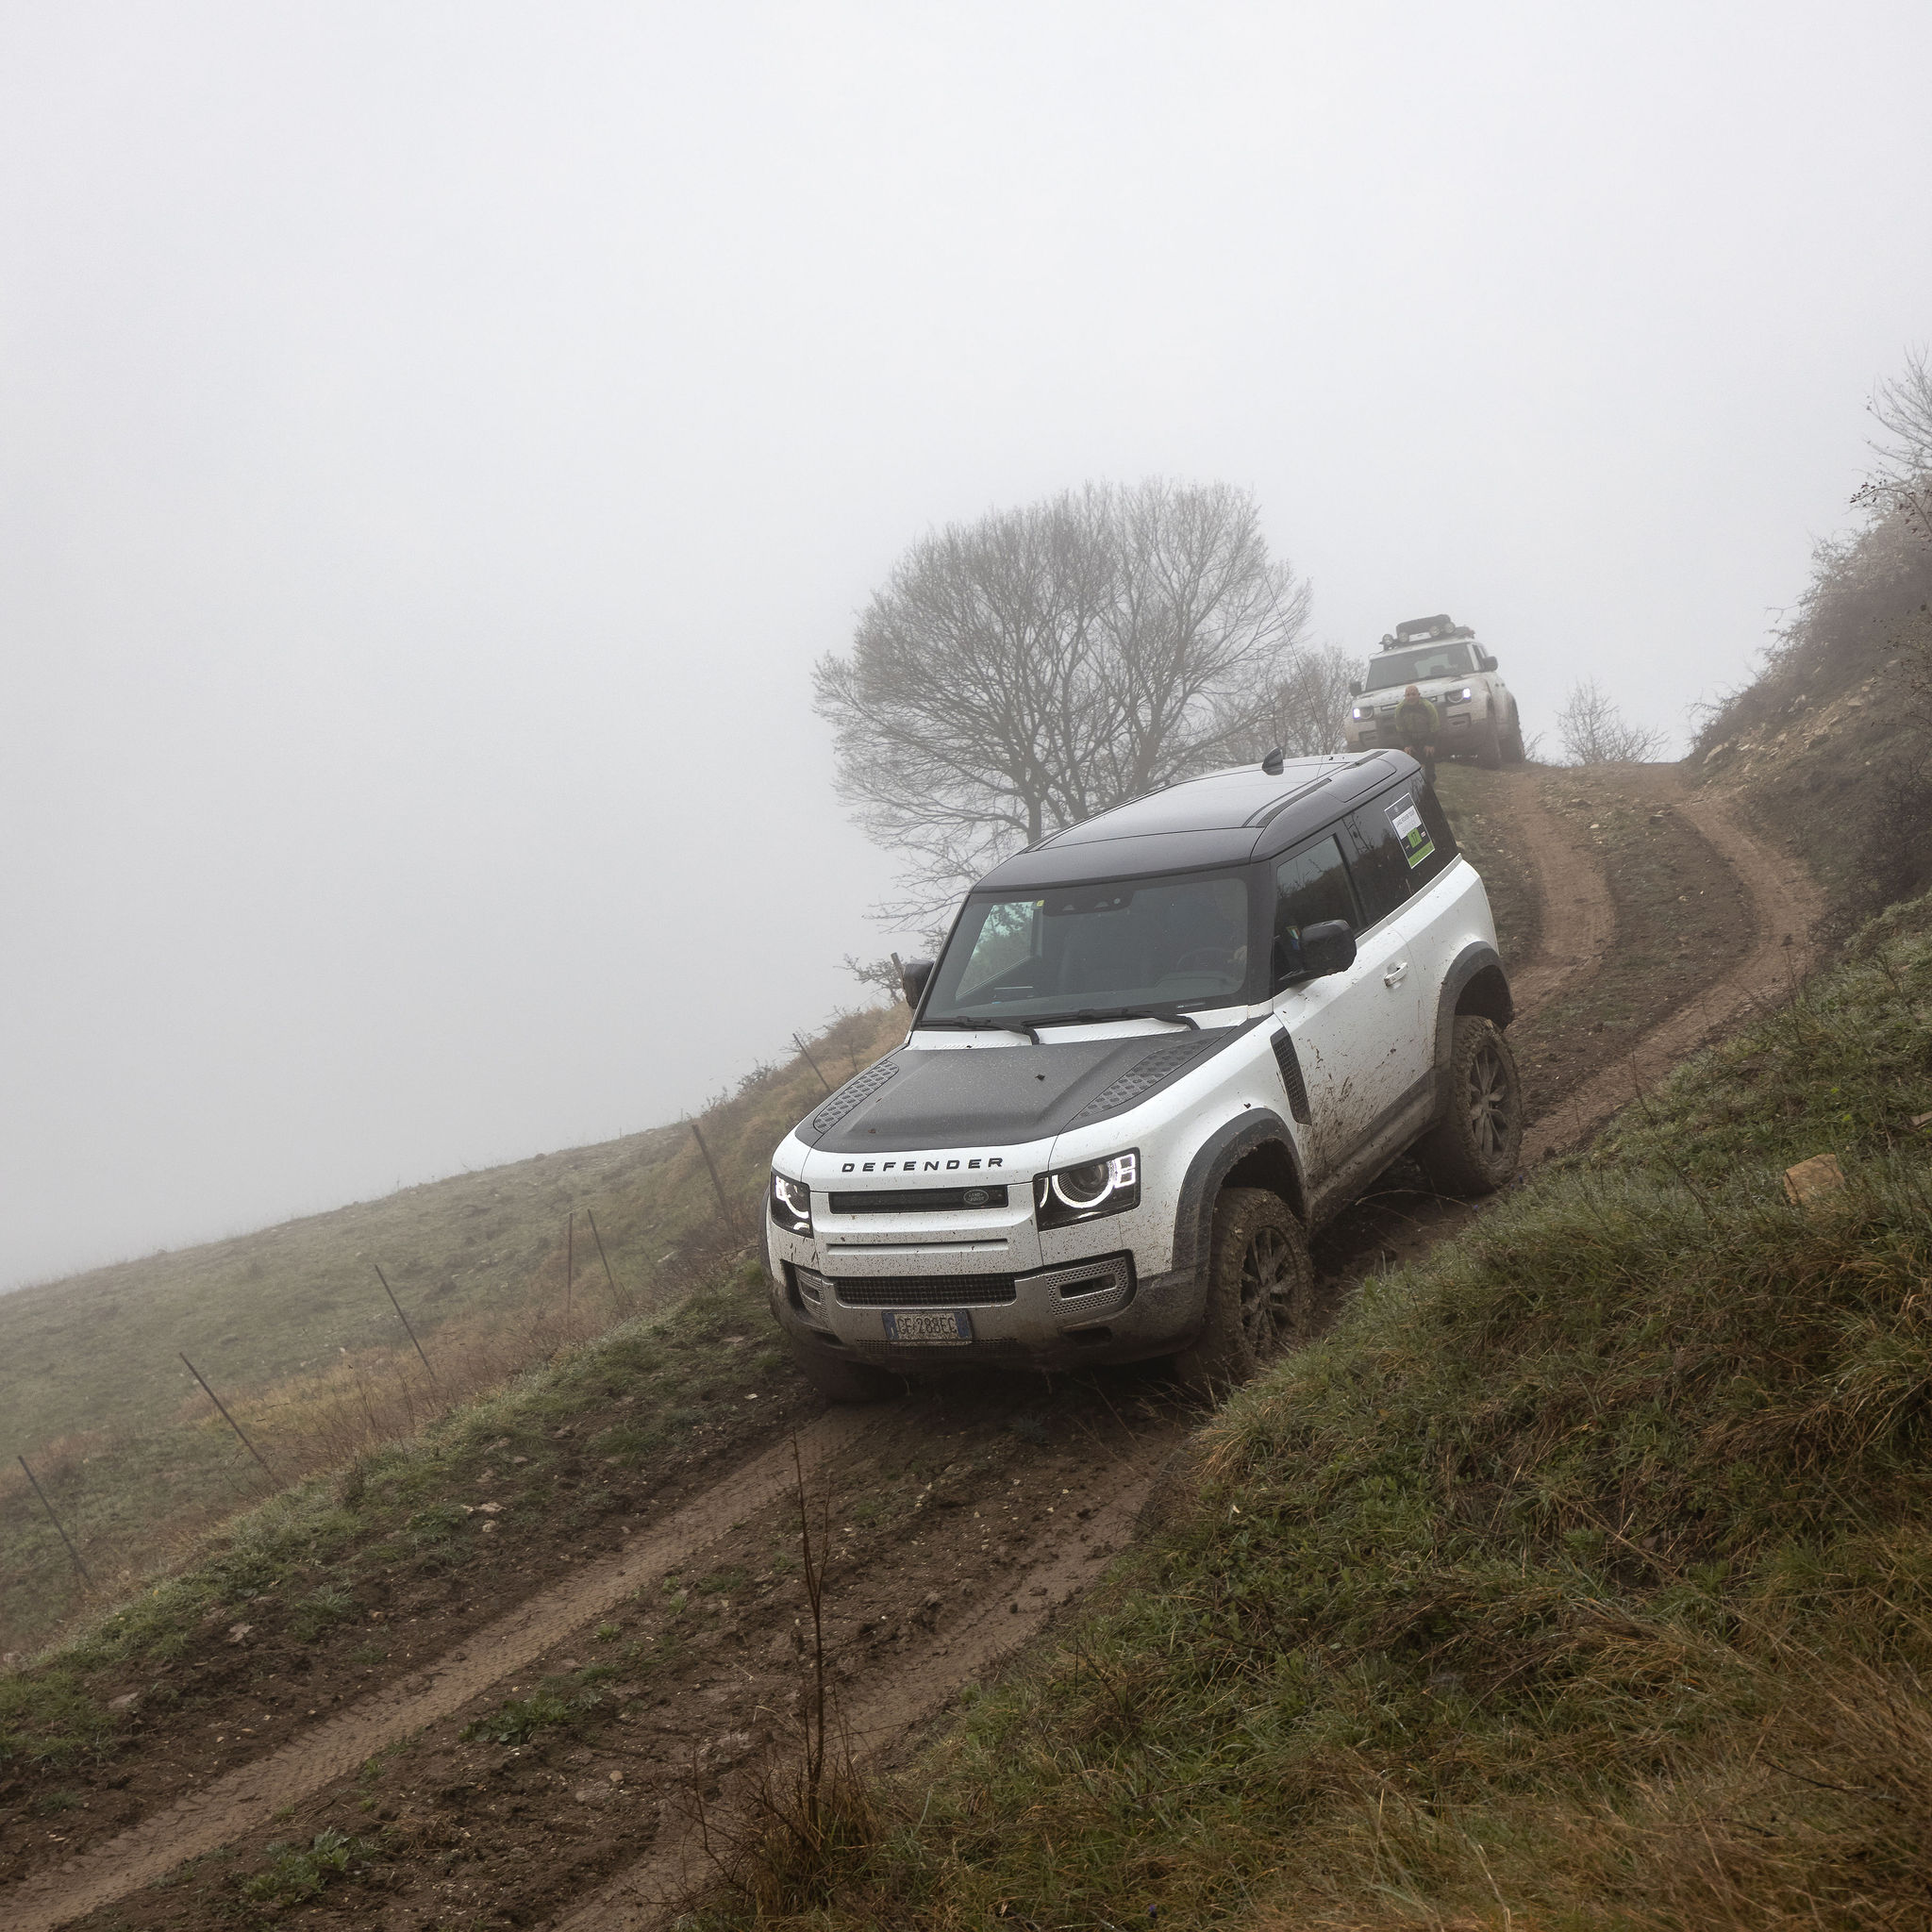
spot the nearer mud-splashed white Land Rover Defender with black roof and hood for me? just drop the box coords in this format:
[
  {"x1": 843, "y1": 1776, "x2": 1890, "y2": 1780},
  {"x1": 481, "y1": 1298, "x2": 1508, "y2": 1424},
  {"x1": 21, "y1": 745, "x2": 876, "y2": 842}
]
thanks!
[{"x1": 765, "y1": 752, "x2": 1523, "y2": 1401}]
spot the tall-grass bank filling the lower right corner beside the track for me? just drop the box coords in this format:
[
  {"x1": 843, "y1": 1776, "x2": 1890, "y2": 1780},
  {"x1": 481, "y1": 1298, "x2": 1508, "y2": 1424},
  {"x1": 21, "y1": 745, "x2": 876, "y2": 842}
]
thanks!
[{"x1": 719, "y1": 900, "x2": 1932, "y2": 1928}]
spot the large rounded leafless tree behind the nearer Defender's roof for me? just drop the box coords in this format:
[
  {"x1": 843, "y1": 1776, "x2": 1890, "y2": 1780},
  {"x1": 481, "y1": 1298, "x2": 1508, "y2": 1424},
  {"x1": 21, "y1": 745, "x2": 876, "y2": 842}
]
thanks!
[{"x1": 813, "y1": 481, "x2": 1307, "y2": 925}]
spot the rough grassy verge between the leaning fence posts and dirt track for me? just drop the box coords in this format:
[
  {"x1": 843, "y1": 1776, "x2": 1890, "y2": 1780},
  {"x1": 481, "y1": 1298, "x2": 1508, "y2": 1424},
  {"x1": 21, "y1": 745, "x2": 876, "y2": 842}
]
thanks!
[{"x1": 0, "y1": 1263, "x2": 796, "y2": 1792}]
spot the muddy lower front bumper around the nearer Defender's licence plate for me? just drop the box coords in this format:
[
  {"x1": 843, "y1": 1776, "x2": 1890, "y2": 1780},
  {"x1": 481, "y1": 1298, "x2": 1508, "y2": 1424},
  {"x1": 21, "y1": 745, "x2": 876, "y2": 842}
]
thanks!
[{"x1": 771, "y1": 1252, "x2": 1206, "y2": 1375}]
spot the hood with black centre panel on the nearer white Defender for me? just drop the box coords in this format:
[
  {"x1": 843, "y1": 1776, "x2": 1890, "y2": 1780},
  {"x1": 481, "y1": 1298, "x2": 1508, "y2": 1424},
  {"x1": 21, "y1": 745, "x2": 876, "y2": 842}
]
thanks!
[{"x1": 796, "y1": 1025, "x2": 1244, "y2": 1154}]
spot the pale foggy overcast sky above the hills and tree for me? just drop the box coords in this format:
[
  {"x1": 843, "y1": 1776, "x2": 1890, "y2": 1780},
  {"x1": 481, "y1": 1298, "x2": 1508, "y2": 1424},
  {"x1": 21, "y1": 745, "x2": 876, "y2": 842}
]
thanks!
[{"x1": 0, "y1": 0, "x2": 1932, "y2": 1283}]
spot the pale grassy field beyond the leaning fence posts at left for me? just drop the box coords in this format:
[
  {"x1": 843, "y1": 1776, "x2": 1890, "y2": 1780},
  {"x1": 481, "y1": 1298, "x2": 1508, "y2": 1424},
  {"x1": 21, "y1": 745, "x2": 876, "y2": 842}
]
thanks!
[{"x1": 0, "y1": 1008, "x2": 904, "y2": 1650}]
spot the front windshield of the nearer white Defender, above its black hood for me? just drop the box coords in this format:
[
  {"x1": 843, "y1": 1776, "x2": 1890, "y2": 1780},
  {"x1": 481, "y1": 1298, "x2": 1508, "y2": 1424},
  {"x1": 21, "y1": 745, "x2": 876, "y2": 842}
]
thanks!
[{"x1": 920, "y1": 874, "x2": 1248, "y2": 1025}]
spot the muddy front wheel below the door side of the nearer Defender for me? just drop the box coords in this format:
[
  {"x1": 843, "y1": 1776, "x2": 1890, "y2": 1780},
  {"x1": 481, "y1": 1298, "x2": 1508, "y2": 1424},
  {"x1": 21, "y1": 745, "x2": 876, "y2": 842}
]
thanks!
[{"x1": 1174, "y1": 1189, "x2": 1316, "y2": 1395}]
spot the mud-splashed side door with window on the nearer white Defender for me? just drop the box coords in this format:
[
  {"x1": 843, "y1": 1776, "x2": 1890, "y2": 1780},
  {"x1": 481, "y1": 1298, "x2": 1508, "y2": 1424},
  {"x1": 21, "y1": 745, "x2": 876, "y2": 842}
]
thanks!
[{"x1": 1274, "y1": 833, "x2": 1416, "y2": 1182}]
